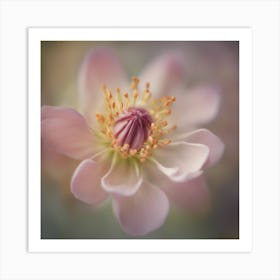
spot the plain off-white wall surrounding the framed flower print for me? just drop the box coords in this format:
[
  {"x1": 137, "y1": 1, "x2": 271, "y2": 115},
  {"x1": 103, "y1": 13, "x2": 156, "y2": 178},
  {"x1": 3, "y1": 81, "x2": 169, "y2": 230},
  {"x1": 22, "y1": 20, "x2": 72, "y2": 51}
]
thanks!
[{"x1": 0, "y1": 0, "x2": 280, "y2": 280}]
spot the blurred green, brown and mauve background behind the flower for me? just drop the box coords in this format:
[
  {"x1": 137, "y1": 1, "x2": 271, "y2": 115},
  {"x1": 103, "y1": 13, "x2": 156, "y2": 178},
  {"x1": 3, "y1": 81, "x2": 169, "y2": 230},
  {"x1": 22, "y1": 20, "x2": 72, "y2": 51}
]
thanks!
[{"x1": 41, "y1": 41, "x2": 239, "y2": 239}]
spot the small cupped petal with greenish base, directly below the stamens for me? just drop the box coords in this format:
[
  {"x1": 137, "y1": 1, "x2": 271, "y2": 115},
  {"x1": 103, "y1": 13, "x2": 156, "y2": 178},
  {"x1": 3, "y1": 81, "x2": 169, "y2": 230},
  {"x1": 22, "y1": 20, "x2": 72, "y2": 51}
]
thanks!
[{"x1": 101, "y1": 157, "x2": 143, "y2": 196}]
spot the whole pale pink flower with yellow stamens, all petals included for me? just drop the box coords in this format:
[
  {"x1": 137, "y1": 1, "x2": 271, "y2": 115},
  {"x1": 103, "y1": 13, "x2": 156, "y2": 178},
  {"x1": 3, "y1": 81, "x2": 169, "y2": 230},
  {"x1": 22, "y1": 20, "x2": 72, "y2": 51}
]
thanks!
[{"x1": 41, "y1": 48, "x2": 224, "y2": 236}]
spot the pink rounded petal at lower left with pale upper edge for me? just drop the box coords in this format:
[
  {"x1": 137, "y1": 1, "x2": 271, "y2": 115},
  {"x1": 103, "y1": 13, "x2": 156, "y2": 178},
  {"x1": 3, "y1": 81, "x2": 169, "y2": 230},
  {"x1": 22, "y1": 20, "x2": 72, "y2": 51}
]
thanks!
[{"x1": 71, "y1": 159, "x2": 107, "y2": 205}]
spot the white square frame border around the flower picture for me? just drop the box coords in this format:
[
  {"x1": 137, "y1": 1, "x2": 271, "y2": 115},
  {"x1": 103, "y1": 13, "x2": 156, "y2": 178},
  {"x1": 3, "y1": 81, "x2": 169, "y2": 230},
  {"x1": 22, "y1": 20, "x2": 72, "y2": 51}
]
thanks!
[{"x1": 28, "y1": 27, "x2": 252, "y2": 252}]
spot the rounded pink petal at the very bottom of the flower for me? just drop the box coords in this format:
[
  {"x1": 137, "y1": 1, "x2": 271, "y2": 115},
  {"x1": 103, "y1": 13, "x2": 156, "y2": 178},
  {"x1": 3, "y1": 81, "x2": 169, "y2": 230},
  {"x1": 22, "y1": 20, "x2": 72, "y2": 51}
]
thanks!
[{"x1": 113, "y1": 182, "x2": 169, "y2": 235}]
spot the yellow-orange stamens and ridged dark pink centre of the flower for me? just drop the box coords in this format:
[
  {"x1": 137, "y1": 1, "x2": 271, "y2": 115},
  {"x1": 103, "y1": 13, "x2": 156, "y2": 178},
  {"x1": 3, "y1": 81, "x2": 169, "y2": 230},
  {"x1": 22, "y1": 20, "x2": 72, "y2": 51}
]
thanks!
[{"x1": 96, "y1": 77, "x2": 176, "y2": 162}]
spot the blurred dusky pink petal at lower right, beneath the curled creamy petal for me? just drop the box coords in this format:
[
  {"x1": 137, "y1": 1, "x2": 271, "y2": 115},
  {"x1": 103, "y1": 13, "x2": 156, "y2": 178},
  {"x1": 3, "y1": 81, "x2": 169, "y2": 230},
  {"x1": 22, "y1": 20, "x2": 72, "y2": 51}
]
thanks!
[{"x1": 164, "y1": 176, "x2": 211, "y2": 214}]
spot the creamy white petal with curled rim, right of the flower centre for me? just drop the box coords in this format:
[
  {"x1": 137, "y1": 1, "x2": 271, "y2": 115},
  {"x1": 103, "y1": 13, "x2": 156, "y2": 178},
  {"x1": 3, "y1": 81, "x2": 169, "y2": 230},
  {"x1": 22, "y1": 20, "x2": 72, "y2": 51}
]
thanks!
[{"x1": 152, "y1": 142, "x2": 209, "y2": 182}]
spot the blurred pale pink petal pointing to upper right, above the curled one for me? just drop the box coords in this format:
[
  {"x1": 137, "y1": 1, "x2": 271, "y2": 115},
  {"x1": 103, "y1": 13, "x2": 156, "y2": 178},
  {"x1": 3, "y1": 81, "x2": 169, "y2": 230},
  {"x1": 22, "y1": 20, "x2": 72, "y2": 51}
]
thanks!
[{"x1": 171, "y1": 86, "x2": 220, "y2": 129}]
